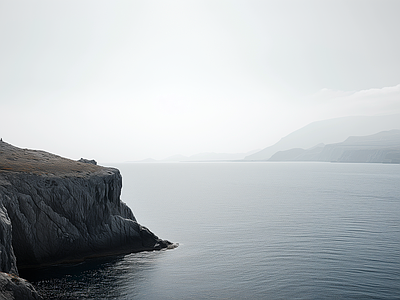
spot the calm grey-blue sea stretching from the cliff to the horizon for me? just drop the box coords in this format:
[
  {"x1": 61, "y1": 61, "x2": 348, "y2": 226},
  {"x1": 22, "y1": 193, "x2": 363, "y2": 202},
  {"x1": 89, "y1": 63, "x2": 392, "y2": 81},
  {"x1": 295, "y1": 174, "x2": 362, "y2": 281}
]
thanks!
[{"x1": 22, "y1": 163, "x2": 400, "y2": 299}]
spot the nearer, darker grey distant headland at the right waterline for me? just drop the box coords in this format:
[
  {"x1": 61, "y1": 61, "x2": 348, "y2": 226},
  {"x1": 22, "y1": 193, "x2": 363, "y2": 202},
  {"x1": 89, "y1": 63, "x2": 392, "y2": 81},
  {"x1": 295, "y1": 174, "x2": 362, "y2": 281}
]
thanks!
[{"x1": 269, "y1": 130, "x2": 400, "y2": 163}]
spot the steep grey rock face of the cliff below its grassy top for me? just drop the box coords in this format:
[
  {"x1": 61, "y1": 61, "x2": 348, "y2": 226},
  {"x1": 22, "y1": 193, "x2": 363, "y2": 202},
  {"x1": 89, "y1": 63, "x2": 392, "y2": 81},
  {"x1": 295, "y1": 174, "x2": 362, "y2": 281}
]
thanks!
[{"x1": 0, "y1": 169, "x2": 172, "y2": 266}]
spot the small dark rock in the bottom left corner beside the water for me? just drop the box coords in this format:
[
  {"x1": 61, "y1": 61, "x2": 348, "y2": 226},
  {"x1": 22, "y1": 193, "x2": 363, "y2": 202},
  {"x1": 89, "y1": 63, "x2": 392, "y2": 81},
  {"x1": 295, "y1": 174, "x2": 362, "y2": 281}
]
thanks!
[{"x1": 0, "y1": 272, "x2": 42, "y2": 300}]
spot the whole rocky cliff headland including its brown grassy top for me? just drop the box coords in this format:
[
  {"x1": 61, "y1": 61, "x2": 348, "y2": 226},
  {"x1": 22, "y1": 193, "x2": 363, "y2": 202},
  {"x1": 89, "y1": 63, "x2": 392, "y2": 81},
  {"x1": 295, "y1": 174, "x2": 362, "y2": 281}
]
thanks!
[{"x1": 0, "y1": 142, "x2": 172, "y2": 273}]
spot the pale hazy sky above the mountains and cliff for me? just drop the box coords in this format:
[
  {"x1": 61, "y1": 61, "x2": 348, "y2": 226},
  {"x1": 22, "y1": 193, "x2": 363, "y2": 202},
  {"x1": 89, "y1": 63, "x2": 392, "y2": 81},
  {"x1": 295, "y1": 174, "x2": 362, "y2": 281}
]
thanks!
[{"x1": 0, "y1": 0, "x2": 400, "y2": 162}]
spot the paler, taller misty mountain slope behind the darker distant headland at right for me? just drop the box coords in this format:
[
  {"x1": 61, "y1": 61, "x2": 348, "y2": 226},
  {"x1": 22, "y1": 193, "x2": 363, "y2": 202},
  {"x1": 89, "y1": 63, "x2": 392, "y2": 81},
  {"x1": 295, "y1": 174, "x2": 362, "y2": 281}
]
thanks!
[{"x1": 245, "y1": 114, "x2": 400, "y2": 160}]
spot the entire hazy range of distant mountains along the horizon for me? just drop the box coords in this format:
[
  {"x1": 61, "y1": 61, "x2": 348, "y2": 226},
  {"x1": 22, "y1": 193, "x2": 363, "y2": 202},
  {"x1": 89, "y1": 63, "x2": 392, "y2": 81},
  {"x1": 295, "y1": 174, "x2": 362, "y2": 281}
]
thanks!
[{"x1": 131, "y1": 114, "x2": 400, "y2": 163}]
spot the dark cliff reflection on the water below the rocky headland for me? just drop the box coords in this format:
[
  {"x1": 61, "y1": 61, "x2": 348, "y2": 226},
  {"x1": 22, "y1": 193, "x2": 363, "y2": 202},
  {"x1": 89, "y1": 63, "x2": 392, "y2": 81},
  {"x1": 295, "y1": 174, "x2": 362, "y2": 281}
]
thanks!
[{"x1": 20, "y1": 252, "x2": 161, "y2": 300}]
